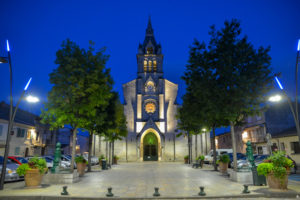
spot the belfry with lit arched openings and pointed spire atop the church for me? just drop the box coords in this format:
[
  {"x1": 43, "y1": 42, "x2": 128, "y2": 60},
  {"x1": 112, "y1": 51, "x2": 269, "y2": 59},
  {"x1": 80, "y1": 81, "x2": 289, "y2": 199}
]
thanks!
[{"x1": 136, "y1": 17, "x2": 163, "y2": 78}]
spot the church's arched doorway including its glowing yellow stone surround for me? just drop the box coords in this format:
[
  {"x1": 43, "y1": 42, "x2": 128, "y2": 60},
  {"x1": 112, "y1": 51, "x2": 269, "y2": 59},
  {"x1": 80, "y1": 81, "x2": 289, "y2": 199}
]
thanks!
[{"x1": 140, "y1": 128, "x2": 161, "y2": 161}]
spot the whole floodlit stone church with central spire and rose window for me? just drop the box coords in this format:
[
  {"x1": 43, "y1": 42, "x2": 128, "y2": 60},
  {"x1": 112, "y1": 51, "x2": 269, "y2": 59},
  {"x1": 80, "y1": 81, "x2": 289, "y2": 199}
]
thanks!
[{"x1": 93, "y1": 19, "x2": 210, "y2": 161}]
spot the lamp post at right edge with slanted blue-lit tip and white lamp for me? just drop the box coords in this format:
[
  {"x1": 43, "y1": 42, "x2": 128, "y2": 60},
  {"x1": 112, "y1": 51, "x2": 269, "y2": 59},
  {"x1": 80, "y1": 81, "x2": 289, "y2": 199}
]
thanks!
[{"x1": 269, "y1": 76, "x2": 300, "y2": 143}]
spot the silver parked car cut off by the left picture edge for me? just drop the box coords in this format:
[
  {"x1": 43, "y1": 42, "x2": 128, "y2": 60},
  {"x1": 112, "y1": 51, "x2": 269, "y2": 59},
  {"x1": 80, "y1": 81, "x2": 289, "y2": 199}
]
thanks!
[{"x1": 0, "y1": 156, "x2": 24, "y2": 182}]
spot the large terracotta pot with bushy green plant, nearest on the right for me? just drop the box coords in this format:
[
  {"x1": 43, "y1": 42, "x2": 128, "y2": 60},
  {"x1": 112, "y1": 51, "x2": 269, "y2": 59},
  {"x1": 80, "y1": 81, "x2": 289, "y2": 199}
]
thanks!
[{"x1": 257, "y1": 151, "x2": 293, "y2": 190}]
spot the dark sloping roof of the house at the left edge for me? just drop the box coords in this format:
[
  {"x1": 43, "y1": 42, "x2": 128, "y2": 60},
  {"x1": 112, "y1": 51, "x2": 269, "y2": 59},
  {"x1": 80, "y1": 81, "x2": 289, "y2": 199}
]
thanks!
[{"x1": 0, "y1": 101, "x2": 40, "y2": 126}]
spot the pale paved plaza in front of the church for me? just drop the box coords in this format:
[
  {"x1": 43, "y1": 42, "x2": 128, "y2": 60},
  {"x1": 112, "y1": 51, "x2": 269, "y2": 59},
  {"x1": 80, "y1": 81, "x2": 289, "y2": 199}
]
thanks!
[{"x1": 0, "y1": 162, "x2": 300, "y2": 199}]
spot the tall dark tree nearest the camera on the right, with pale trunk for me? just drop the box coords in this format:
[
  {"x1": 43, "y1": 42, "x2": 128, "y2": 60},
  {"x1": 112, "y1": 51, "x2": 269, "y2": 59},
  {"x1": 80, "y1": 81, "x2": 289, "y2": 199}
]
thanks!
[{"x1": 209, "y1": 19, "x2": 273, "y2": 170}]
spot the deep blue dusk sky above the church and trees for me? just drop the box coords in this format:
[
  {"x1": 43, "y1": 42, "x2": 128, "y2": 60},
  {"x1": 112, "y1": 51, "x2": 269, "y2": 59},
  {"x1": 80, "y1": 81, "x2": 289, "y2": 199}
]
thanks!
[{"x1": 0, "y1": 0, "x2": 300, "y2": 114}]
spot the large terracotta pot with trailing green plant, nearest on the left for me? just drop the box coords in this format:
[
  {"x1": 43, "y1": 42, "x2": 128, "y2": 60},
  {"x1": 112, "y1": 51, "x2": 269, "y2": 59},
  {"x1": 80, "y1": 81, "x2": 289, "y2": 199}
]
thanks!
[{"x1": 17, "y1": 157, "x2": 48, "y2": 187}]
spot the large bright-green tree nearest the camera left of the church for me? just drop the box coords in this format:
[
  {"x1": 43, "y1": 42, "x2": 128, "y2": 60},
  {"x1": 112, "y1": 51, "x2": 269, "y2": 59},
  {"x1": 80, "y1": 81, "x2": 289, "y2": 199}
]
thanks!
[{"x1": 41, "y1": 39, "x2": 112, "y2": 172}]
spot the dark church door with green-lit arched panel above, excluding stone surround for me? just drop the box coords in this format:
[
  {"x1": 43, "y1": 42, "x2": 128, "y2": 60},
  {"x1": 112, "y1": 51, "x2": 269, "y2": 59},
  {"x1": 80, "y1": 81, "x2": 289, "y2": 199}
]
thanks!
[{"x1": 143, "y1": 132, "x2": 158, "y2": 161}]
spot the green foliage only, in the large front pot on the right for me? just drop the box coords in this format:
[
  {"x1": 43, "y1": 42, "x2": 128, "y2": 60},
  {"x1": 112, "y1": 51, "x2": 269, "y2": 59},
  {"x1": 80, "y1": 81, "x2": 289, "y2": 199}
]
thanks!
[{"x1": 257, "y1": 151, "x2": 294, "y2": 180}]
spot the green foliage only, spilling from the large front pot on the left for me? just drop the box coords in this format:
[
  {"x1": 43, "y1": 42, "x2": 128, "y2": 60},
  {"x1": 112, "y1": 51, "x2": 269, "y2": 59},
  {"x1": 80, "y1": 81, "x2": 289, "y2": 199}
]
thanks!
[{"x1": 16, "y1": 157, "x2": 47, "y2": 176}]
